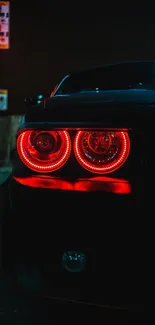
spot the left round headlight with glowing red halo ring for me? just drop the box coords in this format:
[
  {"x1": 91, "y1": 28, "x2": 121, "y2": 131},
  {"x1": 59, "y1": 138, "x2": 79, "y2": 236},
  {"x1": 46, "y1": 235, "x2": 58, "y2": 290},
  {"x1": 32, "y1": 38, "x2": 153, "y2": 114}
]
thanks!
[{"x1": 17, "y1": 130, "x2": 71, "y2": 173}]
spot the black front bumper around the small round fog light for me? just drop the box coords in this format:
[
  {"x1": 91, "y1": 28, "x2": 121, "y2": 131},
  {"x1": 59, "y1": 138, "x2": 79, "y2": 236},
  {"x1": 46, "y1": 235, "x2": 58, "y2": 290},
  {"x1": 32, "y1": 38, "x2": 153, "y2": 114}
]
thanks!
[{"x1": 4, "y1": 178, "x2": 152, "y2": 304}]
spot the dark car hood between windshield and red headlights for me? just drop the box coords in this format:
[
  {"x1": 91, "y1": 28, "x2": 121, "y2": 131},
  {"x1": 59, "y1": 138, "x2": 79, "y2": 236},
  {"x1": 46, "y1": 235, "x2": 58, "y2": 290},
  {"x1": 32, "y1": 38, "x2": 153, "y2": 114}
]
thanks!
[{"x1": 20, "y1": 94, "x2": 155, "y2": 134}]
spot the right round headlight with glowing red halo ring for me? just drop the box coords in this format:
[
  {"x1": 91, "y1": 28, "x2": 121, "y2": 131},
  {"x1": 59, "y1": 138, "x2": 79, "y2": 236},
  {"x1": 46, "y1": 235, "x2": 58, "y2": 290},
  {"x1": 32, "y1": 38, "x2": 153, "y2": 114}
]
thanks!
[{"x1": 74, "y1": 130, "x2": 130, "y2": 174}]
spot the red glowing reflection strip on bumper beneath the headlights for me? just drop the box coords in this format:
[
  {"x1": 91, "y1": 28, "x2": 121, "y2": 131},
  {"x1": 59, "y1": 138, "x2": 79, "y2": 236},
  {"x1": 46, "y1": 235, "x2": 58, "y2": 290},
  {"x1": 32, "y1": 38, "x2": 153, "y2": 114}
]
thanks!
[{"x1": 14, "y1": 175, "x2": 131, "y2": 194}]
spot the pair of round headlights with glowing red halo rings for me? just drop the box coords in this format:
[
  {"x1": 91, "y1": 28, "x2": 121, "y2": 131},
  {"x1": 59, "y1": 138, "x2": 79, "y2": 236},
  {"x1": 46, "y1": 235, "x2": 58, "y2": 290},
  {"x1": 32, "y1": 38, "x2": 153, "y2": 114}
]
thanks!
[{"x1": 17, "y1": 129, "x2": 130, "y2": 175}]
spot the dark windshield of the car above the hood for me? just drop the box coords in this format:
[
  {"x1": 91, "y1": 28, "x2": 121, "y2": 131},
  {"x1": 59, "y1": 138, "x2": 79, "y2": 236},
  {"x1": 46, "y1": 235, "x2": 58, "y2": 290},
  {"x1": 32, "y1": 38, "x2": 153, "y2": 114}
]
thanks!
[{"x1": 56, "y1": 62, "x2": 155, "y2": 95}]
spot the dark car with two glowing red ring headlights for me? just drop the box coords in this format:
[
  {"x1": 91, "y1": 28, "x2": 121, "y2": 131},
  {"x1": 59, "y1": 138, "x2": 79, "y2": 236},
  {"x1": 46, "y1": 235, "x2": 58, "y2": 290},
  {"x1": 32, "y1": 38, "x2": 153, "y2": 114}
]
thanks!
[{"x1": 3, "y1": 62, "x2": 155, "y2": 318}]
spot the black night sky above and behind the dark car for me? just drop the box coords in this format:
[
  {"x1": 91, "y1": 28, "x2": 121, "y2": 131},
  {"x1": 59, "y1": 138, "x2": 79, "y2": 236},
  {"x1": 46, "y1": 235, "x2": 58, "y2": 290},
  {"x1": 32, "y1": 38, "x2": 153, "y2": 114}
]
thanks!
[{"x1": 0, "y1": 0, "x2": 155, "y2": 114}]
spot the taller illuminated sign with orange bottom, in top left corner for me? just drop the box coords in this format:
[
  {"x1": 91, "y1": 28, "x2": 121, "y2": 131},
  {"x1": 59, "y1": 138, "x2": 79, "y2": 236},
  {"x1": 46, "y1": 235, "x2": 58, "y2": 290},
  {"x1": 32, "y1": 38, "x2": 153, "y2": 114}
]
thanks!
[{"x1": 0, "y1": 1, "x2": 10, "y2": 50}]
